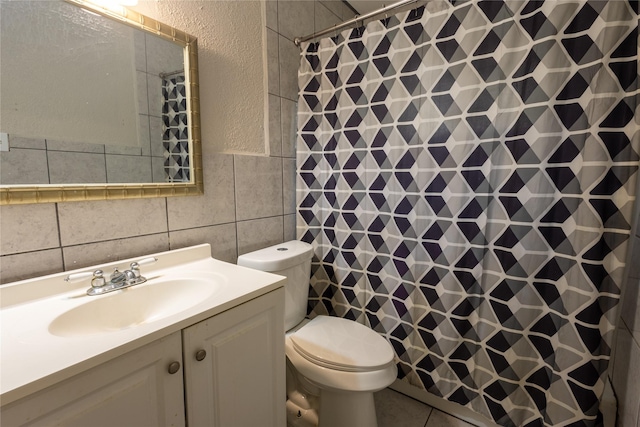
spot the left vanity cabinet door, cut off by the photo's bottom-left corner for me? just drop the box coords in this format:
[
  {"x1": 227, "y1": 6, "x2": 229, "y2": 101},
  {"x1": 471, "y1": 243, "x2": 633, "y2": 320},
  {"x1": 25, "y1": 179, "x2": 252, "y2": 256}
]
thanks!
[{"x1": 2, "y1": 332, "x2": 185, "y2": 427}]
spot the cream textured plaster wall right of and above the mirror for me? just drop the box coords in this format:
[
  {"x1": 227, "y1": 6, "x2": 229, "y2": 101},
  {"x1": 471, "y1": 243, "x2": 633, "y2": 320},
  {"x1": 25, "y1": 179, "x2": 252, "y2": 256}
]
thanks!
[{"x1": 134, "y1": 1, "x2": 266, "y2": 154}]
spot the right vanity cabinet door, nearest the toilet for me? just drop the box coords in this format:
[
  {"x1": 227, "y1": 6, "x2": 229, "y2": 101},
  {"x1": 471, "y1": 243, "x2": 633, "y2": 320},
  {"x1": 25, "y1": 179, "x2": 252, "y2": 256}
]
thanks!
[{"x1": 182, "y1": 288, "x2": 286, "y2": 427}]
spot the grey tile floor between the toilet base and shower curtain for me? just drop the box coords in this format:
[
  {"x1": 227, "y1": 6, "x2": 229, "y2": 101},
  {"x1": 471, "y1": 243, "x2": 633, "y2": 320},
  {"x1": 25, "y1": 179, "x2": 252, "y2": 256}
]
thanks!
[{"x1": 374, "y1": 388, "x2": 473, "y2": 427}]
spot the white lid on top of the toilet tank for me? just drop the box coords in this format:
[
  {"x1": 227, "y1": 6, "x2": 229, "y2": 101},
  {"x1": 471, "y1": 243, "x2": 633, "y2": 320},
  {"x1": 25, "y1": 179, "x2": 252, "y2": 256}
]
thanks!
[{"x1": 238, "y1": 240, "x2": 313, "y2": 271}]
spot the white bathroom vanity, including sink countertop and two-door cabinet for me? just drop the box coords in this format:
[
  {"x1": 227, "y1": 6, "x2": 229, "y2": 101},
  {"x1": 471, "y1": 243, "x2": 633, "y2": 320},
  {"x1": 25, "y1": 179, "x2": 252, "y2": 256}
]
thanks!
[{"x1": 0, "y1": 244, "x2": 286, "y2": 427}]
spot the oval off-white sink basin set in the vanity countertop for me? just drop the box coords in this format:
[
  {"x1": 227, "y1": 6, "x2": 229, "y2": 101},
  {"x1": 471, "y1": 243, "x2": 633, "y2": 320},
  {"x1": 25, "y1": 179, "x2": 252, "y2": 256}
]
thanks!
[{"x1": 49, "y1": 279, "x2": 221, "y2": 337}]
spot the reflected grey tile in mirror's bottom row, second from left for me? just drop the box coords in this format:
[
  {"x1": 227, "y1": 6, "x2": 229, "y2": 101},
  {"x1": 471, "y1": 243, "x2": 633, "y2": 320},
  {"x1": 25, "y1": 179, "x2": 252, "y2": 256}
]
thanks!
[{"x1": 48, "y1": 151, "x2": 107, "y2": 184}]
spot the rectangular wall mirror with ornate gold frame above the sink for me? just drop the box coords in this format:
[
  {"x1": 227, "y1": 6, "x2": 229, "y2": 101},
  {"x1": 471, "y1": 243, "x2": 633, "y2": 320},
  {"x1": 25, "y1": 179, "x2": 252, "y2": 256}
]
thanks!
[{"x1": 0, "y1": 0, "x2": 203, "y2": 204}]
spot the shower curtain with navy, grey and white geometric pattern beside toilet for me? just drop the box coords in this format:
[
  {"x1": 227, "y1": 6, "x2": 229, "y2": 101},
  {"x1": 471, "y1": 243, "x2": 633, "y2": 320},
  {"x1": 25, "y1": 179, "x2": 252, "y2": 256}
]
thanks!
[{"x1": 297, "y1": 0, "x2": 640, "y2": 427}]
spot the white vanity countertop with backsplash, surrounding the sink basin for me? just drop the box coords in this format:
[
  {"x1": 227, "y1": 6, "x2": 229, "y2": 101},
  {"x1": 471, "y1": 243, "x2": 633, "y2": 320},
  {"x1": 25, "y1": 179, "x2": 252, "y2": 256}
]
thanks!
[{"x1": 0, "y1": 245, "x2": 286, "y2": 405}]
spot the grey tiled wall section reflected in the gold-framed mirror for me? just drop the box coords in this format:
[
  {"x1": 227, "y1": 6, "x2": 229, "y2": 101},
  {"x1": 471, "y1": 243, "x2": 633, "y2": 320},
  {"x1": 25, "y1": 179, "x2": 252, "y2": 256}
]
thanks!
[{"x1": 0, "y1": 32, "x2": 178, "y2": 185}]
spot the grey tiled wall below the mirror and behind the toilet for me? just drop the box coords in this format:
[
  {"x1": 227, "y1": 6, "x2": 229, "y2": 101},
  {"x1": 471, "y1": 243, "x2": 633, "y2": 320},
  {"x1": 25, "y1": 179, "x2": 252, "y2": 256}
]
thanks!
[{"x1": 0, "y1": 0, "x2": 354, "y2": 283}]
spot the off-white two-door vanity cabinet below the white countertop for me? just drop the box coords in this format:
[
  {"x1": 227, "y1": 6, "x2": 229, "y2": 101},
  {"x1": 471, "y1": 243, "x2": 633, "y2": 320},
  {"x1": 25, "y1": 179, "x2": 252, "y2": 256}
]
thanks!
[{"x1": 1, "y1": 288, "x2": 286, "y2": 427}]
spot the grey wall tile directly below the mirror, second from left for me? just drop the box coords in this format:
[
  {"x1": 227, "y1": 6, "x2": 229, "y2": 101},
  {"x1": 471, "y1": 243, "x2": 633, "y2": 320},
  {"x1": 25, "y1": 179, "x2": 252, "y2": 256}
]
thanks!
[{"x1": 58, "y1": 198, "x2": 168, "y2": 246}]
